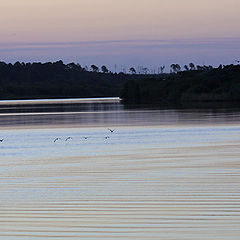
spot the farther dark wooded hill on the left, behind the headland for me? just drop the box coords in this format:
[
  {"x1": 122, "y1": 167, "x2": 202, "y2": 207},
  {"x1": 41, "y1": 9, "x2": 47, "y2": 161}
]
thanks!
[{"x1": 0, "y1": 61, "x2": 153, "y2": 99}]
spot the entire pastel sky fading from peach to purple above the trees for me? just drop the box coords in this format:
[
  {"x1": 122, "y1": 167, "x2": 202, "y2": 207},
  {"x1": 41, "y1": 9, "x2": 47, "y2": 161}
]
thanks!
[{"x1": 0, "y1": 0, "x2": 240, "y2": 71}]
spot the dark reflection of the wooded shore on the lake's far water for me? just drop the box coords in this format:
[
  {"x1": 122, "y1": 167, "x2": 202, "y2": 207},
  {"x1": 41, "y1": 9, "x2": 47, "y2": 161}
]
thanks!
[{"x1": 0, "y1": 98, "x2": 240, "y2": 127}]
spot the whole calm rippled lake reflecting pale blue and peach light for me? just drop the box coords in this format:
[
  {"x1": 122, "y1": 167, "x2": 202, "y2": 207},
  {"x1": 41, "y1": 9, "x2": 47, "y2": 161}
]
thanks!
[{"x1": 0, "y1": 98, "x2": 240, "y2": 240}]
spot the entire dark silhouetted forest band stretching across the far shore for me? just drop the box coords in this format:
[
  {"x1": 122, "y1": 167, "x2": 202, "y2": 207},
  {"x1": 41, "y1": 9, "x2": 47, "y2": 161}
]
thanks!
[{"x1": 0, "y1": 60, "x2": 240, "y2": 104}]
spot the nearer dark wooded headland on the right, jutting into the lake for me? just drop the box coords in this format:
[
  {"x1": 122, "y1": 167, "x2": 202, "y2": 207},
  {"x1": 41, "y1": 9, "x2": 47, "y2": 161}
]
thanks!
[{"x1": 121, "y1": 65, "x2": 240, "y2": 104}]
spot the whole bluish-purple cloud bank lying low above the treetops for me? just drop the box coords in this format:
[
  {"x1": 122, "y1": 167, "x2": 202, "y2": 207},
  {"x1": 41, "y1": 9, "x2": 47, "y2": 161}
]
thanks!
[{"x1": 0, "y1": 38, "x2": 240, "y2": 67}]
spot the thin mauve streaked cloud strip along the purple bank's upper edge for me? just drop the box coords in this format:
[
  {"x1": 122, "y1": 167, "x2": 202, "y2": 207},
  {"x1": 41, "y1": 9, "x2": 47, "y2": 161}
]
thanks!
[{"x1": 0, "y1": 38, "x2": 240, "y2": 51}]
